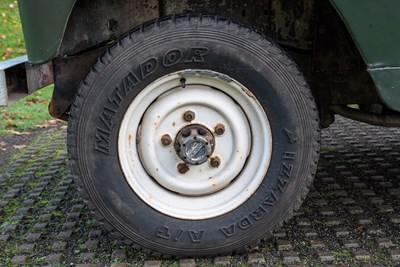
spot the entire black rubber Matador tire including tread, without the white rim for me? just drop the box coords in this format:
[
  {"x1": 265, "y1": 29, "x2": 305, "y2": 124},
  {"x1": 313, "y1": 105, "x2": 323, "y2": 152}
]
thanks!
[{"x1": 68, "y1": 15, "x2": 320, "y2": 257}]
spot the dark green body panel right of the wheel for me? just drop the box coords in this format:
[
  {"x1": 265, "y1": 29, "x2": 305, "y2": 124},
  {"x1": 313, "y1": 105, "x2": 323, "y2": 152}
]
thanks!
[{"x1": 331, "y1": 0, "x2": 400, "y2": 111}]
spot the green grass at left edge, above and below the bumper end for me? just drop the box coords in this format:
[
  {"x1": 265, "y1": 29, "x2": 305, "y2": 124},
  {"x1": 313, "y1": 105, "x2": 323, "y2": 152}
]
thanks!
[{"x1": 0, "y1": 0, "x2": 55, "y2": 136}]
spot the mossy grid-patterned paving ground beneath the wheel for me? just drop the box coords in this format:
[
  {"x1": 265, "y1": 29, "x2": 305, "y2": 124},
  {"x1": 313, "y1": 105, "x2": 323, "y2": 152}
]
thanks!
[{"x1": 0, "y1": 118, "x2": 400, "y2": 267}]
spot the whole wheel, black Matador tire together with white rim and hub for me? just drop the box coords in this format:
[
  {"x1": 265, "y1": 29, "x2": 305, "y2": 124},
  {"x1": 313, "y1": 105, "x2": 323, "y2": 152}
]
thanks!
[{"x1": 68, "y1": 15, "x2": 320, "y2": 257}]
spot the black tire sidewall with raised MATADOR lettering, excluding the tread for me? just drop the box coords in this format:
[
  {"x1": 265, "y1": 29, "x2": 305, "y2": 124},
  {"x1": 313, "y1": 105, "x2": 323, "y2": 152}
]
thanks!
[{"x1": 76, "y1": 24, "x2": 312, "y2": 255}]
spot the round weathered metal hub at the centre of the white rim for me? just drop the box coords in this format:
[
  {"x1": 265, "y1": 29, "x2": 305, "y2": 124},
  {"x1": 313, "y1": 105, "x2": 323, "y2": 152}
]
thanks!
[{"x1": 174, "y1": 124, "x2": 215, "y2": 165}]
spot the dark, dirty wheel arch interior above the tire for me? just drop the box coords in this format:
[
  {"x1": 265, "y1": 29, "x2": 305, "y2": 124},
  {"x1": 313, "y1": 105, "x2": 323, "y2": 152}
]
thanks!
[{"x1": 50, "y1": 0, "x2": 380, "y2": 126}]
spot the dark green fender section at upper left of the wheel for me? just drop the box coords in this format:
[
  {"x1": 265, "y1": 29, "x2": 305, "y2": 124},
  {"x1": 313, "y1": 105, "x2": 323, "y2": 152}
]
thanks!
[{"x1": 18, "y1": 0, "x2": 76, "y2": 64}]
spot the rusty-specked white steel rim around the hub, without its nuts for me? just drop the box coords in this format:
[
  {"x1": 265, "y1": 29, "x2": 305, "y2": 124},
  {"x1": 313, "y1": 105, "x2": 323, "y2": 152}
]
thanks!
[{"x1": 118, "y1": 70, "x2": 272, "y2": 220}]
